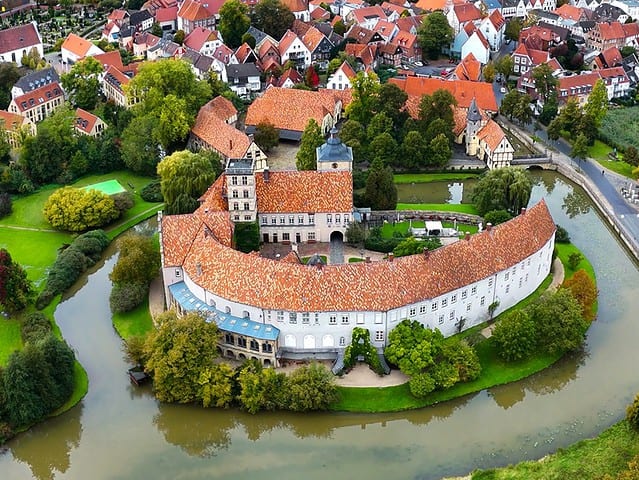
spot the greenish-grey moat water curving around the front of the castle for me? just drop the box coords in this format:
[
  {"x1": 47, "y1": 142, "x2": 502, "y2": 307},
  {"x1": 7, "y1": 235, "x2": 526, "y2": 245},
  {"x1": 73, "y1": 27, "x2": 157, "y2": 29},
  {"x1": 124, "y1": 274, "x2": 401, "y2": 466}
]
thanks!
[{"x1": 0, "y1": 173, "x2": 639, "y2": 479}]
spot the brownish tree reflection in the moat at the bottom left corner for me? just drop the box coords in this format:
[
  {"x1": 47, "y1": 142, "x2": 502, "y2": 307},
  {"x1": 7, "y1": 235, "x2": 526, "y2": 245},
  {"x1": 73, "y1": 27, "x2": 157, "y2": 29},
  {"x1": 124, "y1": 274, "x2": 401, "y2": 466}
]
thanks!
[{"x1": 11, "y1": 404, "x2": 83, "y2": 480}]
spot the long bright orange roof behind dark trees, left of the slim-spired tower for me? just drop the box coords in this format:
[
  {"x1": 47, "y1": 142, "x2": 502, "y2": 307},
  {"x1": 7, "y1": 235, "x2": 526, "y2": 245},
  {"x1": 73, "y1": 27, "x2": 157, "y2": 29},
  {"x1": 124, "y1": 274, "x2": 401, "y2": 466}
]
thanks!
[{"x1": 389, "y1": 77, "x2": 499, "y2": 112}]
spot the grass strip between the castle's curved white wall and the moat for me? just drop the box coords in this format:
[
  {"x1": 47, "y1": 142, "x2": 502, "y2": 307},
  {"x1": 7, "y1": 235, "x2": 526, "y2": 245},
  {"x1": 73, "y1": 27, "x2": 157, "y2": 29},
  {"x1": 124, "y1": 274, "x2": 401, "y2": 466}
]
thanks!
[{"x1": 331, "y1": 244, "x2": 594, "y2": 412}]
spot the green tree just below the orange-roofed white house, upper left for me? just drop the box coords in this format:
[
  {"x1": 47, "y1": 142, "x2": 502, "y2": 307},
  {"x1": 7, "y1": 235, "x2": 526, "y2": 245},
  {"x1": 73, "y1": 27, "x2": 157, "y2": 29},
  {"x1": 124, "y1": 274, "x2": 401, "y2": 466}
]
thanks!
[{"x1": 60, "y1": 57, "x2": 103, "y2": 110}]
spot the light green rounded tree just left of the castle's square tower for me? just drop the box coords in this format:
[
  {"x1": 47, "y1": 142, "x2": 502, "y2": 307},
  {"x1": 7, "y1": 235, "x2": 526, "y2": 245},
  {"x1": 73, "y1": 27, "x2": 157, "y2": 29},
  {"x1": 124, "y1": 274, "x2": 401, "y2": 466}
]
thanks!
[{"x1": 157, "y1": 150, "x2": 219, "y2": 214}]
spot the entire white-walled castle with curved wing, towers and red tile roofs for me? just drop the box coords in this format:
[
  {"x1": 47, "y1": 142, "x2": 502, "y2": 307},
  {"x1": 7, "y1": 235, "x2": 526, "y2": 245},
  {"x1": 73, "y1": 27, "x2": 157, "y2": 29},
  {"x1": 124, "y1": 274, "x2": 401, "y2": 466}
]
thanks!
[{"x1": 159, "y1": 129, "x2": 555, "y2": 370}]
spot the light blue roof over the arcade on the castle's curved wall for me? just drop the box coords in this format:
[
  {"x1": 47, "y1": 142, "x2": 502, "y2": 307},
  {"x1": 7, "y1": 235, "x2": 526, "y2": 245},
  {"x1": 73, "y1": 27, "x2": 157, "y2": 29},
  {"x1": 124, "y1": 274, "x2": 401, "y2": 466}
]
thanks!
[{"x1": 169, "y1": 282, "x2": 280, "y2": 340}]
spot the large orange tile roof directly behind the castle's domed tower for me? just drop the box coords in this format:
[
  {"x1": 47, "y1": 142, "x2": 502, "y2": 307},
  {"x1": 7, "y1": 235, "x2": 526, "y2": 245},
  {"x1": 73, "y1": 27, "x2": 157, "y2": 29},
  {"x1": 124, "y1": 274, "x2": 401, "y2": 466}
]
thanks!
[{"x1": 246, "y1": 87, "x2": 346, "y2": 132}]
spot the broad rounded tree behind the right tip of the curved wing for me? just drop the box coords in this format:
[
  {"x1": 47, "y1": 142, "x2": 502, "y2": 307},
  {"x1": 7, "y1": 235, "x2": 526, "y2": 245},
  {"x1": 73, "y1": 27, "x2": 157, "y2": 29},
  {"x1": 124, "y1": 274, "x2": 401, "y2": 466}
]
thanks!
[{"x1": 472, "y1": 167, "x2": 532, "y2": 215}]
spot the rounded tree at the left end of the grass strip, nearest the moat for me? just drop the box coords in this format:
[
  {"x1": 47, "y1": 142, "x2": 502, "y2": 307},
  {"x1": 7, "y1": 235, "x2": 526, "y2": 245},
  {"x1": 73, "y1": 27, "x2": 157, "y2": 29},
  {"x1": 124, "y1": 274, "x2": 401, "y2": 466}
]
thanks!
[{"x1": 286, "y1": 362, "x2": 338, "y2": 412}]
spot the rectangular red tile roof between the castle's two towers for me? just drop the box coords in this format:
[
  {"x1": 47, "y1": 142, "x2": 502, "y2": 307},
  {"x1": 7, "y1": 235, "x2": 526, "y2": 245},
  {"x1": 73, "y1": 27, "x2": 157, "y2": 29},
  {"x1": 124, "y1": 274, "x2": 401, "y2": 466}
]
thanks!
[{"x1": 255, "y1": 170, "x2": 353, "y2": 213}]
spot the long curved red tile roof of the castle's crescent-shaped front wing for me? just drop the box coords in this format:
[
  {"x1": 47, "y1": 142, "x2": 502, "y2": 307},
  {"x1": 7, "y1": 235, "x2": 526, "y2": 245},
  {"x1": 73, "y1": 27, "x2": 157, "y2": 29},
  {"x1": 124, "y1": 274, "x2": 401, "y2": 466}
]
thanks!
[{"x1": 162, "y1": 200, "x2": 555, "y2": 312}]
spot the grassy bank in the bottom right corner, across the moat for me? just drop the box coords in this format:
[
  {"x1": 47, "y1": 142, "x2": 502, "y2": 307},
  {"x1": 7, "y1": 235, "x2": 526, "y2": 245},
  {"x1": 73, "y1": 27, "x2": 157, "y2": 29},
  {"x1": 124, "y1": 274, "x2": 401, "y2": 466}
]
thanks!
[{"x1": 472, "y1": 420, "x2": 639, "y2": 480}]
